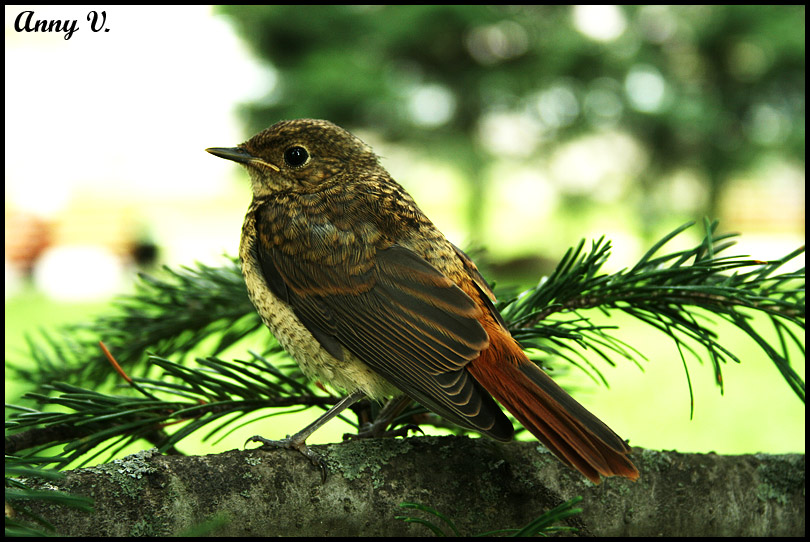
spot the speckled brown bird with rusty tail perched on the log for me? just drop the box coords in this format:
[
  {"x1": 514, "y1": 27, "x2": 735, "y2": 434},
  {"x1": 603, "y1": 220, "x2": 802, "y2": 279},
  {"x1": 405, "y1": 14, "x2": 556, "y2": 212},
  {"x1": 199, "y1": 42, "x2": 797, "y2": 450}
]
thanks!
[{"x1": 206, "y1": 119, "x2": 639, "y2": 483}]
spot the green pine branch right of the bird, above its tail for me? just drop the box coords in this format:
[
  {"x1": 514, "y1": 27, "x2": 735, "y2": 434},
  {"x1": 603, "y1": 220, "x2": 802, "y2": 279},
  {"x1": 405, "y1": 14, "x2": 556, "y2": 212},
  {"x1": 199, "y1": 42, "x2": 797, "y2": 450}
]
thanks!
[{"x1": 499, "y1": 222, "x2": 805, "y2": 410}]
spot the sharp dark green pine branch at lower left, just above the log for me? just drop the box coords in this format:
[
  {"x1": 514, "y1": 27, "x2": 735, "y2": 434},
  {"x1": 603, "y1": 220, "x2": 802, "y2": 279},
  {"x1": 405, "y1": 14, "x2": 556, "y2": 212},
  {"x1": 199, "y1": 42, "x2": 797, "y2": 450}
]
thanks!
[{"x1": 5, "y1": 353, "x2": 340, "y2": 467}]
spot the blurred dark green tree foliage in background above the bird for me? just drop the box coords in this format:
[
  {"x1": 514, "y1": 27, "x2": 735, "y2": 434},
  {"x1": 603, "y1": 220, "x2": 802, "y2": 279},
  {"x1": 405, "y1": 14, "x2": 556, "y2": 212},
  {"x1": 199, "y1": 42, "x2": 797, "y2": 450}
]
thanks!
[{"x1": 219, "y1": 5, "x2": 805, "y2": 242}]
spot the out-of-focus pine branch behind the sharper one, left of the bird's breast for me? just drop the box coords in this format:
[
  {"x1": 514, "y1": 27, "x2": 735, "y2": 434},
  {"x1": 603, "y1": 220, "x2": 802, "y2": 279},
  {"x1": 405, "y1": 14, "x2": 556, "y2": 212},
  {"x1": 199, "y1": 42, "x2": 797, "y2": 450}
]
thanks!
[{"x1": 7, "y1": 258, "x2": 266, "y2": 392}]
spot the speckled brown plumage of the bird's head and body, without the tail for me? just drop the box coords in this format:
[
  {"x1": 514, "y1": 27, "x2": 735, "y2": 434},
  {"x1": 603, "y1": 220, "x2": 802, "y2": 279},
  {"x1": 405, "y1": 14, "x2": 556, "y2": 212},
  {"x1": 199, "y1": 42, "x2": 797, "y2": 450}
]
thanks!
[{"x1": 234, "y1": 121, "x2": 512, "y2": 439}]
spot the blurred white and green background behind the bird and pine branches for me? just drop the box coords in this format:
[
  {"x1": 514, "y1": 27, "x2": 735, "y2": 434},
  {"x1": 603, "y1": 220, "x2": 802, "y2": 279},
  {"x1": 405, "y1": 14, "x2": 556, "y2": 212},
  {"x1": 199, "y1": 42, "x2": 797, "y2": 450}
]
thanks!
[{"x1": 5, "y1": 5, "x2": 805, "y2": 460}]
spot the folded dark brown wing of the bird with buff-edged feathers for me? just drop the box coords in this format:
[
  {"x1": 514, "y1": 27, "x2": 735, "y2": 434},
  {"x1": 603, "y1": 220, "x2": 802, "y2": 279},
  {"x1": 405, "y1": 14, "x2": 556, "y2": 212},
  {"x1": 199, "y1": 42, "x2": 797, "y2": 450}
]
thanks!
[{"x1": 255, "y1": 208, "x2": 513, "y2": 440}]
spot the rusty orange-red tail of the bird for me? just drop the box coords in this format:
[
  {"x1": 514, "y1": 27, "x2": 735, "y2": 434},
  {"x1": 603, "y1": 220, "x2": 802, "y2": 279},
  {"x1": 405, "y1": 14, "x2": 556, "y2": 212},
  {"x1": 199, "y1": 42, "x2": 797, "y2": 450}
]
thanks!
[{"x1": 467, "y1": 329, "x2": 638, "y2": 484}]
